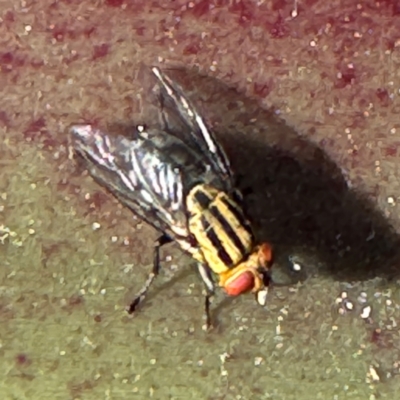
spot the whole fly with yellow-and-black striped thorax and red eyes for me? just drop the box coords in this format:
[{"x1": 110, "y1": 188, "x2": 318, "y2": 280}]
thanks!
[{"x1": 71, "y1": 67, "x2": 272, "y2": 326}]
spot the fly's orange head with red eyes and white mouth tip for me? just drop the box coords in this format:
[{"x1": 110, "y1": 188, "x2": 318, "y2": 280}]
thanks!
[{"x1": 219, "y1": 243, "x2": 272, "y2": 306}]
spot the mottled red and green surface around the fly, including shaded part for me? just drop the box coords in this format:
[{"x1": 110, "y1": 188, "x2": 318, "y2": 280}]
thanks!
[{"x1": 0, "y1": 0, "x2": 400, "y2": 400}]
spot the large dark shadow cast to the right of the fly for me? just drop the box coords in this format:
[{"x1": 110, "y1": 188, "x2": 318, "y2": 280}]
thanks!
[{"x1": 138, "y1": 69, "x2": 400, "y2": 284}]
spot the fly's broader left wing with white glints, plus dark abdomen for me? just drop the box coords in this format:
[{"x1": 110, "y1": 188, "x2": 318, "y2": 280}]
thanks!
[{"x1": 71, "y1": 125, "x2": 208, "y2": 239}]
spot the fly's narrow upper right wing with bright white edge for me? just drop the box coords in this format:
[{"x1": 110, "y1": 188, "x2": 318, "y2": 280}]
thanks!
[{"x1": 152, "y1": 67, "x2": 234, "y2": 192}]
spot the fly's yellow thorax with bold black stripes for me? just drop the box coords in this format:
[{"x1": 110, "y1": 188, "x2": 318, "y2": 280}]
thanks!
[{"x1": 186, "y1": 184, "x2": 254, "y2": 274}]
